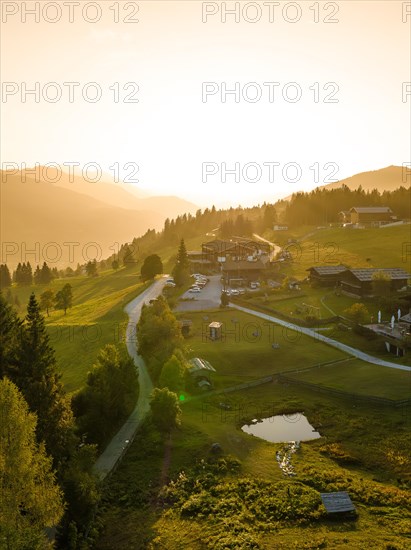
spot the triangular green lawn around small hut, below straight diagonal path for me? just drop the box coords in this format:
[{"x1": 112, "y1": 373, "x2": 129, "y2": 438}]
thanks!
[{"x1": 178, "y1": 309, "x2": 346, "y2": 389}]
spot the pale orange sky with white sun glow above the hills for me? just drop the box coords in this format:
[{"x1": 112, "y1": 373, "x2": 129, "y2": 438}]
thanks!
[{"x1": 0, "y1": 0, "x2": 411, "y2": 207}]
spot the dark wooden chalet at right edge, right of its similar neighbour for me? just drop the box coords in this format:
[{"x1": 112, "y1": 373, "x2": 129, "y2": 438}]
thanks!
[{"x1": 338, "y1": 267, "x2": 411, "y2": 297}]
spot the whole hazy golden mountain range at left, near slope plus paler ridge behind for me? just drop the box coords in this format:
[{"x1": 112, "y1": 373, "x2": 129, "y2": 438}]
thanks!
[{"x1": 0, "y1": 169, "x2": 198, "y2": 267}]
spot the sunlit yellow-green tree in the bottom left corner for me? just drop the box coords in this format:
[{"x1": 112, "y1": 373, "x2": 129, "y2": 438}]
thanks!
[{"x1": 0, "y1": 379, "x2": 64, "y2": 550}]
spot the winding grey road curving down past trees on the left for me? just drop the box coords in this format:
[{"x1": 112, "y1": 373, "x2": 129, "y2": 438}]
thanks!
[{"x1": 94, "y1": 277, "x2": 165, "y2": 480}]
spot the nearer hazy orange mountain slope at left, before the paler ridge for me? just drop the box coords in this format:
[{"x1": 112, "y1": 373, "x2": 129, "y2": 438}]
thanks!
[{"x1": 1, "y1": 171, "x2": 164, "y2": 267}]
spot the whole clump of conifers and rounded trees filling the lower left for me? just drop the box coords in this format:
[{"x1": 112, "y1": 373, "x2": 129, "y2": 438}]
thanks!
[{"x1": 0, "y1": 292, "x2": 138, "y2": 550}]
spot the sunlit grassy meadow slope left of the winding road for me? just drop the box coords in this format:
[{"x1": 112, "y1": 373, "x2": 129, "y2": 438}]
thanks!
[{"x1": 11, "y1": 267, "x2": 151, "y2": 393}]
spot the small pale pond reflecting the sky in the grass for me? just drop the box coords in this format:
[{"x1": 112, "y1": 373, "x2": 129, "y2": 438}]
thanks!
[{"x1": 241, "y1": 413, "x2": 321, "y2": 443}]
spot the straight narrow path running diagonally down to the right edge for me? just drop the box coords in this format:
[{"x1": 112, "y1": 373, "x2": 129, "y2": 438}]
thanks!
[{"x1": 230, "y1": 302, "x2": 411, "y2": 371}]
